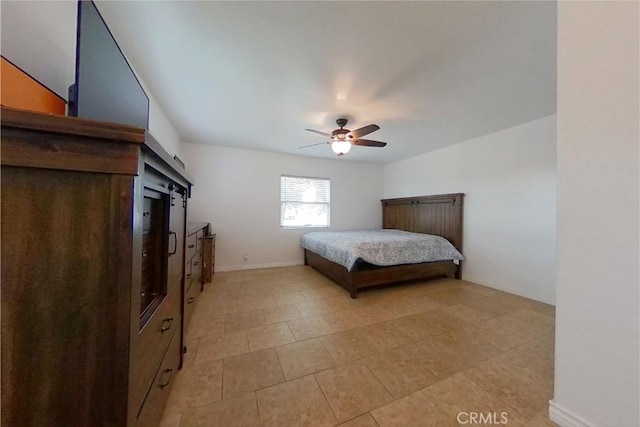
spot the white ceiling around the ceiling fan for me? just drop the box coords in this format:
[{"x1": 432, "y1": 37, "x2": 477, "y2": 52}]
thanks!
[{"x1": 99, "y1": 1, "x2": 556, "y2": 163}]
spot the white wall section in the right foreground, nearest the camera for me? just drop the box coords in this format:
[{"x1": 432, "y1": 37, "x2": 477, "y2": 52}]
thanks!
[{"x1": 550, "y1": 2, "x2": 640, "y2": 427}]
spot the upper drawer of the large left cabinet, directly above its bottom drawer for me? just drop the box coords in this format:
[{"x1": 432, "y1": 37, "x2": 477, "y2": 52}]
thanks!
[{"x1": 131, "y1": 286, "x2": 181, "y2": 412}]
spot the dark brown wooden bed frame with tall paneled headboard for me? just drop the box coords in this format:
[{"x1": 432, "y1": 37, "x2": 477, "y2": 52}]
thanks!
[{"x1": 304, "y1": 193, "x2": 464, "y2": 299}]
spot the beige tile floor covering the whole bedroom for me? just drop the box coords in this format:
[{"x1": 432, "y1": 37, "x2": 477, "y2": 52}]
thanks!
[{"x1": 162, "y1": 266, "x2": 554, "y2": 427}]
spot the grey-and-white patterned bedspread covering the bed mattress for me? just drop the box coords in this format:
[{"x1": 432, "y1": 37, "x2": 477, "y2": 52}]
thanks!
[{"x1": 300, "y1": 229, "x2": 464, "y2": 271}]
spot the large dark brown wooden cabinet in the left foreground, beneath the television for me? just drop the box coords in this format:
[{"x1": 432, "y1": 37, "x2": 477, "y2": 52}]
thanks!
[{"x1": 1, "y1": 108, "x2": 191, "y2": 426}]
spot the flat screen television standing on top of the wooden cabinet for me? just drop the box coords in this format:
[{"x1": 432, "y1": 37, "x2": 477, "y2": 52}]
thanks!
[{"x1": 68, "y1": 0, "x2": 149, "y2": 129}]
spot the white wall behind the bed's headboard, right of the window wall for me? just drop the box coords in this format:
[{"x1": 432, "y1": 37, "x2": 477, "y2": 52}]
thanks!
[{"x1": 384, "y1": 116, "x2": 556, "y2": 304}]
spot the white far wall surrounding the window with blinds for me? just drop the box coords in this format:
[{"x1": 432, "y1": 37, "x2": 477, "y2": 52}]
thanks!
[{"x1": 182, "y1": 143, "x2": 383, "y2": 271}]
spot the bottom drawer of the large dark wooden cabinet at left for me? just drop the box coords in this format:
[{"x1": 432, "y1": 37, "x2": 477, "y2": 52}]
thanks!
[{"x1": 136, "y1": 334, "x2": 180, "y2": 427}]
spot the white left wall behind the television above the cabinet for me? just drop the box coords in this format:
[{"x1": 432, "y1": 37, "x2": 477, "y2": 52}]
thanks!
[{"x1": 0, "y1": 1, "x2": 181, "y2": 155}]
